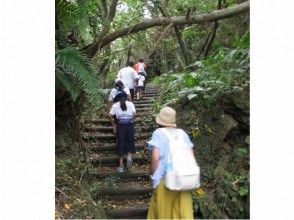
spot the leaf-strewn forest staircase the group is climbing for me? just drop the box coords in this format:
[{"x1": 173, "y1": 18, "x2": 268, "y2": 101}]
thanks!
[{"x1": 81, "y1": 86, "x2": 158, "y2": 219}]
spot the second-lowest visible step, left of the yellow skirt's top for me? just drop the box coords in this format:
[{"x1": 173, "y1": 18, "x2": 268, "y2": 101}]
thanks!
[{"x1": 94, "y1": 187, "x2": 153, "y2": 200}]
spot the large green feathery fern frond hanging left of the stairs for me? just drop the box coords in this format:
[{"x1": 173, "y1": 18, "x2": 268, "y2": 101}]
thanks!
[{"x1": 55, "y1": 47, "x2": 101, "y2": 103}]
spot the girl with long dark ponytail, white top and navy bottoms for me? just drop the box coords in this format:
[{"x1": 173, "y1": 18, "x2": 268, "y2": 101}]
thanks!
[{"x1": 108, "y1": 95, "x2": 136, "y2": 173}]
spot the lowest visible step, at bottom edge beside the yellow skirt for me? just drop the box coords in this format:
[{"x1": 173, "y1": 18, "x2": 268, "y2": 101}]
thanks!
[{"x1": 106, "y1": 206, "x2": 148, "y2": 219}]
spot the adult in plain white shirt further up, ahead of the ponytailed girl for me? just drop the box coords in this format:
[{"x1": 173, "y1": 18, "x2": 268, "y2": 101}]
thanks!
[{"x1": 117, "y1": 62, "x2": 138, "y2": 101}]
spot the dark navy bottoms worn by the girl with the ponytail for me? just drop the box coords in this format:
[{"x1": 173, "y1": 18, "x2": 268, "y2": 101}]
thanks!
[{"x1": 116, "y1": 123, "x2": 135, "y2": 156}]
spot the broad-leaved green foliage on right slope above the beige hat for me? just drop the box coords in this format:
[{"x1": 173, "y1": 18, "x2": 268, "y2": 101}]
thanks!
[{"x1": 153, "y1": 41, "x2": 249, "y2": 106}]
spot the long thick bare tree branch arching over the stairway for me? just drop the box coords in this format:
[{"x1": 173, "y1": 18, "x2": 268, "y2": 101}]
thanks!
[{"x1": 82, "y1": 0, "x2": 250, "y2": 57}]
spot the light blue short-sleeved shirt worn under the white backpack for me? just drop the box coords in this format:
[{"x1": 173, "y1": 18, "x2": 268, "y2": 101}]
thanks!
[{"x1": 148, "y1": 128, "x2": 193, "y2": 188}]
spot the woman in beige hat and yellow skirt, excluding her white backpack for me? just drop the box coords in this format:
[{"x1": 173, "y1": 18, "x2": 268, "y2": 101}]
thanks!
[{"x1": 147, "y1": 107, "x2": 193, "y2": 219}]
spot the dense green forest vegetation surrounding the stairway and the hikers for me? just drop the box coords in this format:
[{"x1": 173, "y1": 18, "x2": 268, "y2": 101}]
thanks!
[{"x1": 55, "y1": 0, "x2": 250, "y2": 218}]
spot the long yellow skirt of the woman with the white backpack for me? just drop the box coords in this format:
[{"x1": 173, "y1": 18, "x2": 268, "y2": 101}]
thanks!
[{"x1": 147, "y1": 180, "x2": 193, "y2": 219}]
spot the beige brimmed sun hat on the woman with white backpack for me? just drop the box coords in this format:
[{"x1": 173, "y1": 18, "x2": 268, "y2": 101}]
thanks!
[{"x1": 155, "y1": 107, "x2": 177, "y2": 127}]
